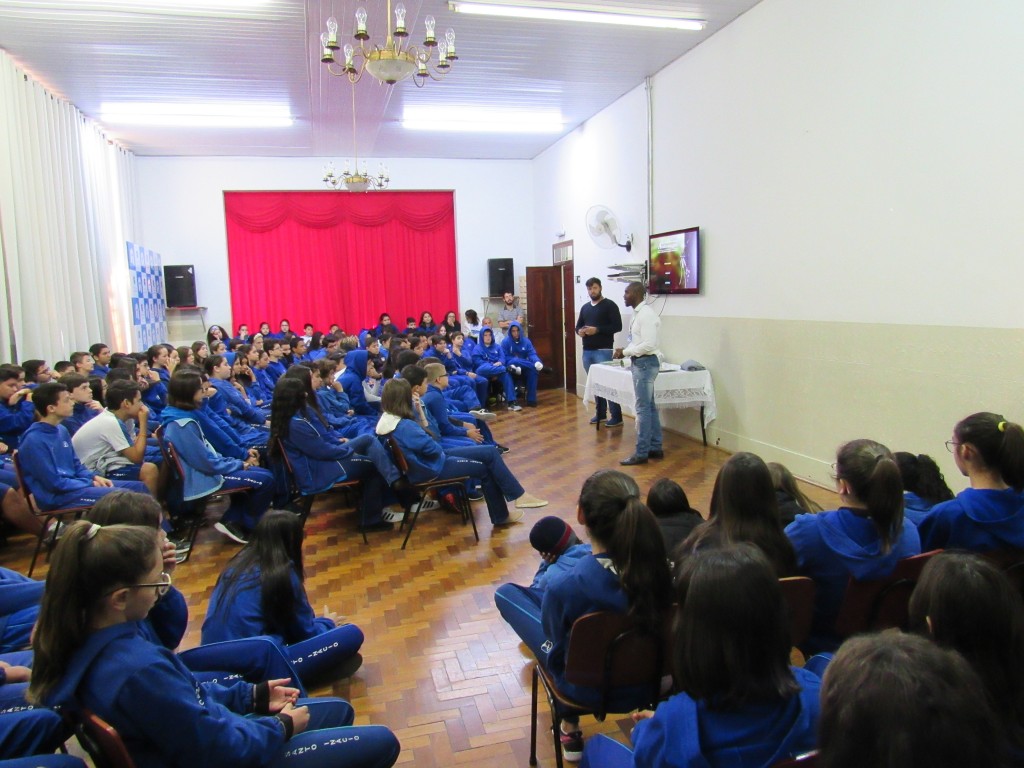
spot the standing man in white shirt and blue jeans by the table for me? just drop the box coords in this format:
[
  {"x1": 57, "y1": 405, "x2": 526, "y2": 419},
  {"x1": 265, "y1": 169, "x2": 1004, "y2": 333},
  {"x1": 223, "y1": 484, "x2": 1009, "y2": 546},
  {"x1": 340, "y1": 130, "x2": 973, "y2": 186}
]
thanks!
[{"x1": 612, "y1": 283, "x2": 665, "y2": 467}]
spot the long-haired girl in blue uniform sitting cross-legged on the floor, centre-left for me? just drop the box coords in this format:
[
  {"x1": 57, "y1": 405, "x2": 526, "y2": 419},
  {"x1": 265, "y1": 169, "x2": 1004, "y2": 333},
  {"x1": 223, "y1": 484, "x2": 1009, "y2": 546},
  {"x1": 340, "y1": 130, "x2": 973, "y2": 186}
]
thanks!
[{"x1": 203, "y1": 511, "x2": 364, "y2": 684}]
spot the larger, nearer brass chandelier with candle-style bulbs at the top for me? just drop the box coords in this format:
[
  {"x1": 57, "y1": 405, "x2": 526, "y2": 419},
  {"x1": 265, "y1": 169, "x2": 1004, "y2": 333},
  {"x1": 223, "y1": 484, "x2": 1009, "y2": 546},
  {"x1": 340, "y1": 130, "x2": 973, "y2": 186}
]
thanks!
[{"x1": 321, "y1": 0, "x2": 459, "y2": 88}]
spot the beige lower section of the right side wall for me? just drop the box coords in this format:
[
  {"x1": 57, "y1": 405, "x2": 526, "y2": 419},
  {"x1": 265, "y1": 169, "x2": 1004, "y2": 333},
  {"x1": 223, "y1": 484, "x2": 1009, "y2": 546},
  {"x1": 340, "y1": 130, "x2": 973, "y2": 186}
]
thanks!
[{"x1": 647, "y1": 317, "x2": 1024, "y2": 489}]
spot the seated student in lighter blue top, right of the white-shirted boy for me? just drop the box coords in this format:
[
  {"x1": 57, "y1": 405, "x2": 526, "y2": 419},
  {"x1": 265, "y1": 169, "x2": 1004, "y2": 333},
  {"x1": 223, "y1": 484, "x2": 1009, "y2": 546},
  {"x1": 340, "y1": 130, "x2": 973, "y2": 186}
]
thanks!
[{"x1": 161, "y1": 371, "x2": 273, "y2": 544}]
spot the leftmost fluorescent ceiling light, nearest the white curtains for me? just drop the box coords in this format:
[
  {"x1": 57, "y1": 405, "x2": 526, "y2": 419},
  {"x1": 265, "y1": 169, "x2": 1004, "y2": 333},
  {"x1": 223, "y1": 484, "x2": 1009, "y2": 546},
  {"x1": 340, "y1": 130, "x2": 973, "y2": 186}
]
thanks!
[{"x1": 99, "y1": 101, "x2": 295, "y2": 128}]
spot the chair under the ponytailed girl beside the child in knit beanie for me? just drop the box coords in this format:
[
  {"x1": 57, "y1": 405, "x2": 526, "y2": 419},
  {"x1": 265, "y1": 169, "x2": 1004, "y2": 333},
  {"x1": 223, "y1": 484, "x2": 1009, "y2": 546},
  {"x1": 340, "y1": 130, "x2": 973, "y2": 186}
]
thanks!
[{"x1": 529, "y1": 611, "x2": 671, "y2": 768}]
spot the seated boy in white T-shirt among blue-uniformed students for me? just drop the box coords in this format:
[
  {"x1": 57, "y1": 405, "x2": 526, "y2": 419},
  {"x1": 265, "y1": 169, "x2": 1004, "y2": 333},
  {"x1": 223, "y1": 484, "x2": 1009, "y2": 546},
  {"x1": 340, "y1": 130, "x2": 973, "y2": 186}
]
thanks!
[{"x1": 71, "y1": 381, "x2": 160, "y2": 496}]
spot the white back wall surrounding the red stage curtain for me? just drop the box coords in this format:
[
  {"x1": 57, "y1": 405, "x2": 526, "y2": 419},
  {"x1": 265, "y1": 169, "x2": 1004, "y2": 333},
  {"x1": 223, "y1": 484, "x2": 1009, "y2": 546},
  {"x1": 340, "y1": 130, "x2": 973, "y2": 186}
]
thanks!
[{"x1": 137, "y1": 158, "x2": 536, "y2": 333}]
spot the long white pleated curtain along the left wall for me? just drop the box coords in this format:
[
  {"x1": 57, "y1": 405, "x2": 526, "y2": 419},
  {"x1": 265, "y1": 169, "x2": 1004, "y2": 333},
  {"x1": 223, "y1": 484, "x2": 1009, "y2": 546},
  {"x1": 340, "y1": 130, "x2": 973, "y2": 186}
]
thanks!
[{"x1": 0, "y1": 50, "x2": 137, "y2": 365}]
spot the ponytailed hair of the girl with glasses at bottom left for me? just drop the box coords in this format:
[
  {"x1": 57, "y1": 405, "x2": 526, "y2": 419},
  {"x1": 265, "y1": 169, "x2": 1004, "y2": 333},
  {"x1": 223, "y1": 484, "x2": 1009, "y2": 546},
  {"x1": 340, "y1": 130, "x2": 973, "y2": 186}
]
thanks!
[{"x1": 27, "y1": 521, "x2": 159, "y2": 705}]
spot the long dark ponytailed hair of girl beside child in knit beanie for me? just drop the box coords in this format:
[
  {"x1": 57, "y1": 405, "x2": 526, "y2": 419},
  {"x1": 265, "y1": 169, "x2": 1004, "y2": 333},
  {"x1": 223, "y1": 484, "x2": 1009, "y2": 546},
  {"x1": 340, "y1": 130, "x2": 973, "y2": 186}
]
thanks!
[{"x1": 580, "y1": 470, "x2": 672, "y2": 632}]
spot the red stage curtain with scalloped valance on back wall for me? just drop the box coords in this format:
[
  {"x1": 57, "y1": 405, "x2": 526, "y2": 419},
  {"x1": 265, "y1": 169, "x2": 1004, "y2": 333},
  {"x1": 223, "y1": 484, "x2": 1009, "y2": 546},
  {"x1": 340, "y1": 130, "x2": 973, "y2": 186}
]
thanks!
[{"x1": 224, "y1": 190, "x2": 459, "y2": 333}]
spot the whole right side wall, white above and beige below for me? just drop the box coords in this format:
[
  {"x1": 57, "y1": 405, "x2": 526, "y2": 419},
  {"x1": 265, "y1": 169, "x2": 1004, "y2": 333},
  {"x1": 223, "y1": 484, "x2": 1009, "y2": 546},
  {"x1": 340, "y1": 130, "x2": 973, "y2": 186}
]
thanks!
[{"x1": 535, "y1": 0, "x2": 1024, "y2": 486}]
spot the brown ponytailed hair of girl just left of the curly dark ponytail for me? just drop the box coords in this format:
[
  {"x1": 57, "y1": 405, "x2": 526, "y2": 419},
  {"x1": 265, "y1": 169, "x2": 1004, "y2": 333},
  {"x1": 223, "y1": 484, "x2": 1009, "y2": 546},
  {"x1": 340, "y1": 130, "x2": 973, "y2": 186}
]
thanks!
[{"x1": 836, "y1": 439, "x2": 903, "y2": 554}]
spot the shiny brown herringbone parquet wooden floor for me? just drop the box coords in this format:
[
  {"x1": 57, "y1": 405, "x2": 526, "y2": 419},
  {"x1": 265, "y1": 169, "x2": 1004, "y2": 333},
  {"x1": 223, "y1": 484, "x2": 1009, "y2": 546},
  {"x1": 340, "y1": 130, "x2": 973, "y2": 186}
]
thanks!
[{"x1": 0, "y1": 390, "x2": 829, "y2": 768}]
